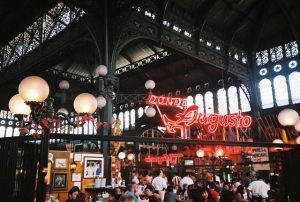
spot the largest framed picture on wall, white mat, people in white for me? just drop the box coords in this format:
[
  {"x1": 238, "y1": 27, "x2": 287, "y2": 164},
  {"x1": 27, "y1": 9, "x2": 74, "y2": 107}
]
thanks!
[{"x1": 83, "y1": 156, "x2": 104, "y2": 178}]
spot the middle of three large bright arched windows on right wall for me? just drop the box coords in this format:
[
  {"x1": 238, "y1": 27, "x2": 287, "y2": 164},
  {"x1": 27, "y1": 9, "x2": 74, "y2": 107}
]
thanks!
[{"x1": 274, "y1": 75, "x2": 289, "y2": 106}]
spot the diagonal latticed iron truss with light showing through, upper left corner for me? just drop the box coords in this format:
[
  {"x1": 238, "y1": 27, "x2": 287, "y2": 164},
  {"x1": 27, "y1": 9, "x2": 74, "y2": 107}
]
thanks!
[{"x1": 0, "y1": 3, "x2": 85, "y2": 73}]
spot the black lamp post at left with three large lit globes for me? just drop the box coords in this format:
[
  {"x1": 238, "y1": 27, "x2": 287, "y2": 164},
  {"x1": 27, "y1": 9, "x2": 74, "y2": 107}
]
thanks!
[{"x1": 9, "y1": 76, "x2": 97, "y2": 202}]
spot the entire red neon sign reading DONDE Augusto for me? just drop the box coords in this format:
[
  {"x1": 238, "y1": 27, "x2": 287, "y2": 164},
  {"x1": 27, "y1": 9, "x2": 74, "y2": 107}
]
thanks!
[{"x1": 147, "y1": 95, "x2": 252, "y2": 134}]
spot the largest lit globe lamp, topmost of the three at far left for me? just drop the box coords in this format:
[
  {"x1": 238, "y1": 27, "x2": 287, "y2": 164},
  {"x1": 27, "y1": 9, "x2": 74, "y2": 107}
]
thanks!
[{"x1": 19, "y1": 76, "x2": 49, "y2": 102}]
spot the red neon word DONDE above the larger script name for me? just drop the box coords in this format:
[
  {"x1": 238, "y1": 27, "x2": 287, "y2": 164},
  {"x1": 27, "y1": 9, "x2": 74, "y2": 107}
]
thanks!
[{"x1": 146, "y1": 95, "x2": 187, "y2": 107}]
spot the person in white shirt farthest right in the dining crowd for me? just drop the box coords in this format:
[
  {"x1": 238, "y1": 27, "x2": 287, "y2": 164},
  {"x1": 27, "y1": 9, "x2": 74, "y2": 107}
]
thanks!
[{"x1": 248, "y1": 177, "x2": 270, "y2": 199}]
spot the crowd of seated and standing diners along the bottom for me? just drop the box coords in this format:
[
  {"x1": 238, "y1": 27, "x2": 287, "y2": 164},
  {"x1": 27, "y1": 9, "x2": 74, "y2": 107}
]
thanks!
[{"x1": 46, "y1": 172, "x2": 285, "y2": 202}]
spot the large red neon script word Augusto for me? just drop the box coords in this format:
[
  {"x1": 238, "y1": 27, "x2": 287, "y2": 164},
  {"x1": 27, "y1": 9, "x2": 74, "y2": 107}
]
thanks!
[{"x1": 162, "y1": 105, "x2": 252, "y2": 133}]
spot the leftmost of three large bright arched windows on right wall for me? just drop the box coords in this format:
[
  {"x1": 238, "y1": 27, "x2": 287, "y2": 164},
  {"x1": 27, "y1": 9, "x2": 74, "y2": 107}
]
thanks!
[{"x1": 258, "y1": 79, "x2": 274, "y2": 109}]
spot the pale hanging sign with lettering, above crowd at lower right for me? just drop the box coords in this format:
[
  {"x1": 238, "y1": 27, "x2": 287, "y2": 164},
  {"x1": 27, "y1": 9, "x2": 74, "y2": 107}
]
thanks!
[{"x1": 252, "y1": 147, "x2": 270, "y2": 170}]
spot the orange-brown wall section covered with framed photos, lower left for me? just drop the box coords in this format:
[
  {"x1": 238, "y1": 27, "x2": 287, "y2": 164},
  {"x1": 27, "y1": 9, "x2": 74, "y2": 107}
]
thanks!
[{"x1": 47, "y1": 150, "x2": 104, "y2": 201}]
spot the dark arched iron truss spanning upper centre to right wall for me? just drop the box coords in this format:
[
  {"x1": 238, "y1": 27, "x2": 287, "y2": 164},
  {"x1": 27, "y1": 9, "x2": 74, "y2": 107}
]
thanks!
[{"x1": 113, "y1": 1, "x2": 249, "y2": 80}]
